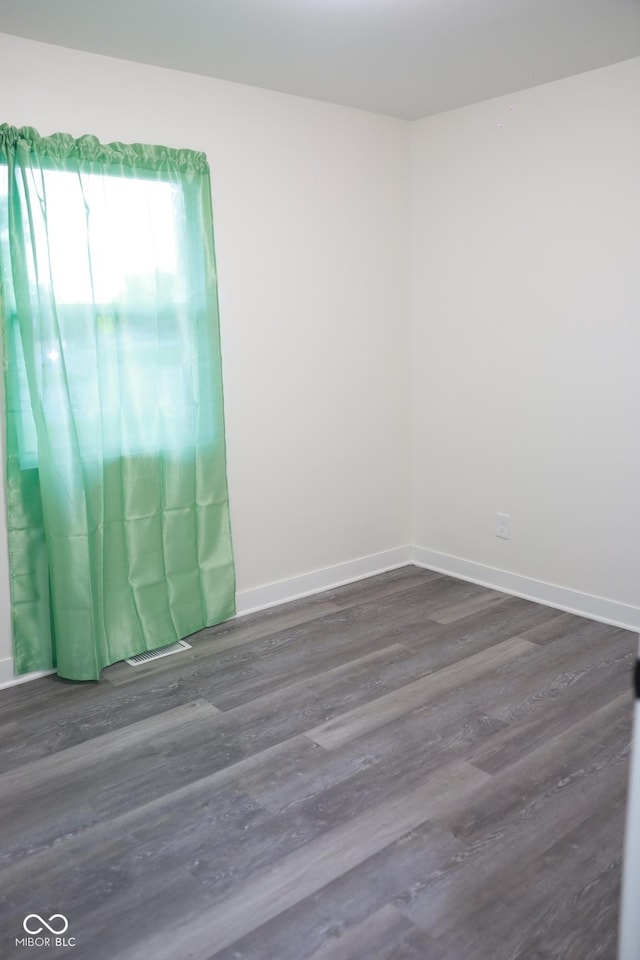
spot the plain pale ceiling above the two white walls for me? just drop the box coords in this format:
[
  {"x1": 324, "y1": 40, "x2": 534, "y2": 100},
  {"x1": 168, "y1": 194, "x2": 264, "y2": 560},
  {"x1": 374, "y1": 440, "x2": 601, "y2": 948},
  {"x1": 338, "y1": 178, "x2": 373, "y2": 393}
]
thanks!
[{"x1": 0, "y1": 0, "x2": 640, "y2": 120}]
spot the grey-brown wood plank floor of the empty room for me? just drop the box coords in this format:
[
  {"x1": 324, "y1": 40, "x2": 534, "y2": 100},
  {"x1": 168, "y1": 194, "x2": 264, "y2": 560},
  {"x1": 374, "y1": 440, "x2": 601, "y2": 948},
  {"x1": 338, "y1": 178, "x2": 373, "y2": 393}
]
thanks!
[{"x1": 0, "y1": 567, "x2": 636, "y2": 960}]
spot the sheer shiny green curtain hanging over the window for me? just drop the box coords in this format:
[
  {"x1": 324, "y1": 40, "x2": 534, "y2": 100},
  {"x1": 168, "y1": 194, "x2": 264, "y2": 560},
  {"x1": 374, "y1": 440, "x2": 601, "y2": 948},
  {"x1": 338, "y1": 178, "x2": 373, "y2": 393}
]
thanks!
[{"x1": 0, "y1": 125, "x2": 235, "y2": 680}]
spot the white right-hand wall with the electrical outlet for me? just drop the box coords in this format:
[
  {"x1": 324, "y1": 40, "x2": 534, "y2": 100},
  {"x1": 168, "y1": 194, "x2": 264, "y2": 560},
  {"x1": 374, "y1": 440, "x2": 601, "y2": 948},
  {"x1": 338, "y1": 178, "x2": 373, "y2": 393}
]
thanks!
[{"x1": 412, "y1": 60, "x2": 640, "y2": 622}]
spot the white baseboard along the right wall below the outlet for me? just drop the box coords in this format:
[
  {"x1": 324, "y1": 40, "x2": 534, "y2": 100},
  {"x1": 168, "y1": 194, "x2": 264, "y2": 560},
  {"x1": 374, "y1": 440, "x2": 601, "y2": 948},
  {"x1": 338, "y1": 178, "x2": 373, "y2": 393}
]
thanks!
[{"x1": 410, "y1": 547, "x2": 640, "y2": 631}]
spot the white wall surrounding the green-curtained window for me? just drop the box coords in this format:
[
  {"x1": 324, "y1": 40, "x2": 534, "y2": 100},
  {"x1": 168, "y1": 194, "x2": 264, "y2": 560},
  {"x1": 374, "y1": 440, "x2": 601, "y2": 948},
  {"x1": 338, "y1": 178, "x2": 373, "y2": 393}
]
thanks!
[{"x1": 0, "y1": 35, "x2": 410, "y2": 679}]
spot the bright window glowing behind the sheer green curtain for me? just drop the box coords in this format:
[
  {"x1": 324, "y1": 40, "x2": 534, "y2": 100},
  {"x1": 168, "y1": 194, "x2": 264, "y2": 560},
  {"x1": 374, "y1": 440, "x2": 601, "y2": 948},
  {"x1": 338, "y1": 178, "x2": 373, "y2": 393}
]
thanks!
[{"x1": 0, "y1": 160, "x2": 215, "y2": 466}]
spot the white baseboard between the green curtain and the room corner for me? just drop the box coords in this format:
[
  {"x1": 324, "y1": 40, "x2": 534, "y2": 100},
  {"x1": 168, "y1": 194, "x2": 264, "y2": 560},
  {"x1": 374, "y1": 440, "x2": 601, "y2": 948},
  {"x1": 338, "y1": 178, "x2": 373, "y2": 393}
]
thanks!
[{"x1": 236, "y1": 547, "x2": 412, "y2": 617}]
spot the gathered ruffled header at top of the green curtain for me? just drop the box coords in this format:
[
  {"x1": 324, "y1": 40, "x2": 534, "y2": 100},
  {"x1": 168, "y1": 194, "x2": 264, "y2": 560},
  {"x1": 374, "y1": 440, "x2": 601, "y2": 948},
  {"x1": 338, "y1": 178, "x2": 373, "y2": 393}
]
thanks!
[{"x1": 0, "y1": 123, "x2": 209, "y2": 174}]
